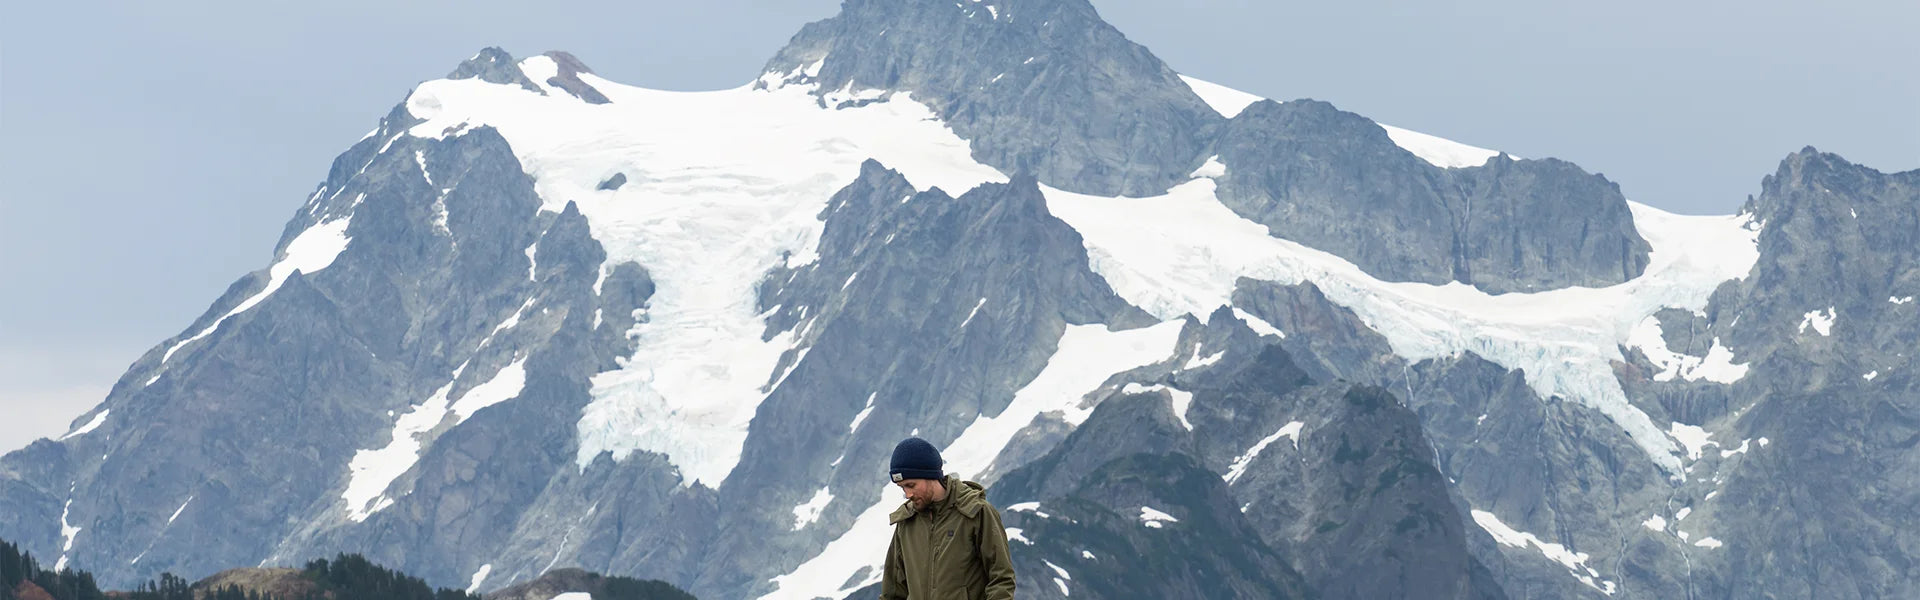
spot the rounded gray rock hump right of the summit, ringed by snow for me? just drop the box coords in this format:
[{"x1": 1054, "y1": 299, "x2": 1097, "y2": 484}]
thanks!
[{"x1": 1213, "y1": 100, "x2": 1649, "y2": 292}]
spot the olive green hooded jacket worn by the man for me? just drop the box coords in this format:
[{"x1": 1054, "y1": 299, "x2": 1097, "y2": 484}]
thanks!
[{"x1": 879, "y1": 475, "x2": 1014, "y2": 600}]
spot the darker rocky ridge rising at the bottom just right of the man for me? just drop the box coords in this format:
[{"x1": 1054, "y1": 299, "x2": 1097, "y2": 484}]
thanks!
[{"x1": 989, "y1": 323, "x2": 1505, "y2": 598}]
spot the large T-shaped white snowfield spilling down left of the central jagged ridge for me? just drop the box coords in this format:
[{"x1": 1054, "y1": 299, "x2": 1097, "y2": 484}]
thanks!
[{"x1": 407, "y1": 56, "x2": 1006, "y2": 487}]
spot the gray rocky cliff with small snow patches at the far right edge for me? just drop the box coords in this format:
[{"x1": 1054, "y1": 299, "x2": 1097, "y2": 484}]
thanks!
[{"x1": 1686, "y1": 148, "x2": 1920, "y2": 598}]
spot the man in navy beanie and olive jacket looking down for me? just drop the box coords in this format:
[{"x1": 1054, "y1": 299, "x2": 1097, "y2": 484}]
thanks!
[{"x1": 879, "y1": 437, "x2": 1014, "y2": 600}]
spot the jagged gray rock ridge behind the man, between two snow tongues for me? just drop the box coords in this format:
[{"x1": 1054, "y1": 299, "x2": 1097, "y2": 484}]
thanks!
[{"x1": 706, "y1": 162, "x2": 1152, "y2": 596}]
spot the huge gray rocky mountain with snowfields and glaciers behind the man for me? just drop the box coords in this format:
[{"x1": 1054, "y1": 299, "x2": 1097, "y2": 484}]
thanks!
[{"x1": 0, "y1": 0, "x2": 1920, "y2": 598}]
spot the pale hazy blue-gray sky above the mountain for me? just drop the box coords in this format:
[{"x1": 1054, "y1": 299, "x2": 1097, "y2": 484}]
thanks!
[{"x1": 0, "y1": 0, "x2": 1920, "y2": 452}]
